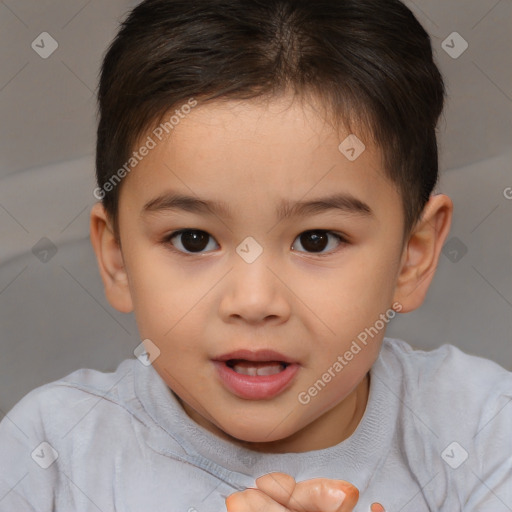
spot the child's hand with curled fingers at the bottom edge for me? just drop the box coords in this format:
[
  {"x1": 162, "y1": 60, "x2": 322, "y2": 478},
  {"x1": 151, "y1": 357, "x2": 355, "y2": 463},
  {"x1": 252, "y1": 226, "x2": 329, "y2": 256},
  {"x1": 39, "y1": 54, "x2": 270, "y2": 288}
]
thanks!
[{"x1": 226, "y1": 473, "x2": 385, "y2": 512}]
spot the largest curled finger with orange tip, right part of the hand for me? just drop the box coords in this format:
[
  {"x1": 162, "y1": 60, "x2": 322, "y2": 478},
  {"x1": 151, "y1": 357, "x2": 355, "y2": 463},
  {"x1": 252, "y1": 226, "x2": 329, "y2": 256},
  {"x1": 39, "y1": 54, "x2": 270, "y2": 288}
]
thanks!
[{"x1": 288, "y1": 478, "x2": 359, "y2": 512}]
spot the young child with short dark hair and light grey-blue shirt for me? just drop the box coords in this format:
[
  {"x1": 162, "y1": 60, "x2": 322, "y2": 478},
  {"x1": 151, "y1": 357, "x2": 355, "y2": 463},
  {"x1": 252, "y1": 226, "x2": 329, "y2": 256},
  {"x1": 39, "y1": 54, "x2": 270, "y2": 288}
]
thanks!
[{"x1": 0, "y1": 0, "x2": 512, "y2": 512}]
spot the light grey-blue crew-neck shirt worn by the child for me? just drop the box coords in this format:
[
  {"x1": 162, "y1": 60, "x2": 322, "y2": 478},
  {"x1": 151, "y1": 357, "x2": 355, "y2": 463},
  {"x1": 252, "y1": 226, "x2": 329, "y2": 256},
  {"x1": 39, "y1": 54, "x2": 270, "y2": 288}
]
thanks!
[{"x1": 0, "y1": 338, "x2": 512, "y2": 512}]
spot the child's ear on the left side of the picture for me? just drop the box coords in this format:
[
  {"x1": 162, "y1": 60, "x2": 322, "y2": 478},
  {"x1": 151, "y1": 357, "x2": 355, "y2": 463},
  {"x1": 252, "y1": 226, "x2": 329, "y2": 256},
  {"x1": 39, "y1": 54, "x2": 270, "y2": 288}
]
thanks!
[{"x1": 90, "y1": 203, "x2": 133, "y2": 313}]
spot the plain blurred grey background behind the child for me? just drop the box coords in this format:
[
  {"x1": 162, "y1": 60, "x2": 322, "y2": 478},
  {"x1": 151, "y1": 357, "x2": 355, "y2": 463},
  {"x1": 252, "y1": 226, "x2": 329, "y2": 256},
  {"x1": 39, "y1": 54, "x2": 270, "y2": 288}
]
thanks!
[{"x1": 0, "y1": 0, "x2": 512, "y2": 412}]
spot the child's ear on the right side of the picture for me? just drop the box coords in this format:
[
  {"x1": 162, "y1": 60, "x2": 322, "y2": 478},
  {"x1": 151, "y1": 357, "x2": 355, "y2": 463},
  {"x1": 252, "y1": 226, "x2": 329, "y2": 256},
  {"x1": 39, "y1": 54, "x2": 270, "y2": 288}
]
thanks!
[{"x1": 394, "y1": 194, "x2": 453, "y2": 313}]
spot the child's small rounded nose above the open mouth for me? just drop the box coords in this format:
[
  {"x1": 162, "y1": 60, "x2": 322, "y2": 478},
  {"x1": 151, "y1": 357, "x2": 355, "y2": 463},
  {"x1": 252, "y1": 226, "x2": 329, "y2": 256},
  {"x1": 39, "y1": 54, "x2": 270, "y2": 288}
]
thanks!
[{"x1": 219, "y1": 252, "x2": 291, "y2": 325}]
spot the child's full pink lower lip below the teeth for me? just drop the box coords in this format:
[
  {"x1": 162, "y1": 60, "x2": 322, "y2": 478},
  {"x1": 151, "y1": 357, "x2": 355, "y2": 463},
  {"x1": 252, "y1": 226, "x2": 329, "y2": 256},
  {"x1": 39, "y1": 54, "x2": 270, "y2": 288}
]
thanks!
[{"x1": 214, "y1": 361, "x2": 299, "y2": 400}]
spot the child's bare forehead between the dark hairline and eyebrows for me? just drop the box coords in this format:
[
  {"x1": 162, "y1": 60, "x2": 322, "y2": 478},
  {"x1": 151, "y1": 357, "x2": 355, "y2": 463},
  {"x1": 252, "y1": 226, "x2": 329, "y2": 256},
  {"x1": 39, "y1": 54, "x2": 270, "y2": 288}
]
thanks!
[{"x1": 121, "y1": 97, "x2": 396, "y2": 223}]
